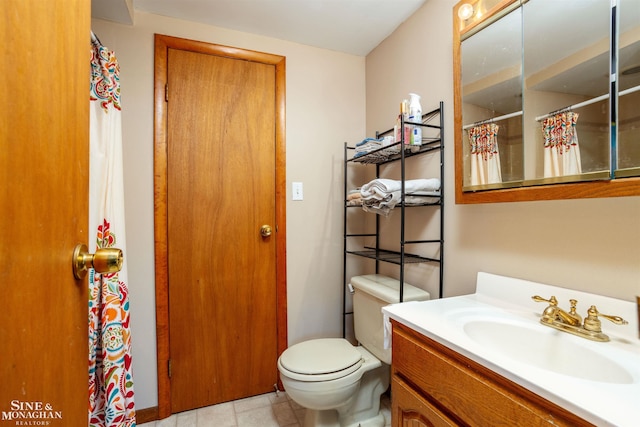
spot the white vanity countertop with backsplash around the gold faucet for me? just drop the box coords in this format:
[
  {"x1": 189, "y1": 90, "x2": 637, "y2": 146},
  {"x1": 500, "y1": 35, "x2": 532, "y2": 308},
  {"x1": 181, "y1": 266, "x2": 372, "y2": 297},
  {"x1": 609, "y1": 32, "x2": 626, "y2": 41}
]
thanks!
[{"x1": 382, "y1": 273, "x2": 640, "y2": 427}]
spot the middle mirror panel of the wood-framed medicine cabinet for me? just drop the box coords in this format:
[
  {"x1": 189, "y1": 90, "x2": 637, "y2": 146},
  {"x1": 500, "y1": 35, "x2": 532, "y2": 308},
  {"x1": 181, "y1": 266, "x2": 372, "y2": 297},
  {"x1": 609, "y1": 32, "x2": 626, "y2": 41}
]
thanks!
[{"x1": 523, "y1": 0, "x2": 611, "y2": 184}]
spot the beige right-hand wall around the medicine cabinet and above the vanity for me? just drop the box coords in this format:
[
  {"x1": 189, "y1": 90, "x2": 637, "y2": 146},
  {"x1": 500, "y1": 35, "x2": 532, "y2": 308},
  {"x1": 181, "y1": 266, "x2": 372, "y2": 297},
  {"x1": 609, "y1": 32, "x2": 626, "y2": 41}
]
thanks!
[{"x1": 366, "y1": 0, "x2": 640, "y2": 300}]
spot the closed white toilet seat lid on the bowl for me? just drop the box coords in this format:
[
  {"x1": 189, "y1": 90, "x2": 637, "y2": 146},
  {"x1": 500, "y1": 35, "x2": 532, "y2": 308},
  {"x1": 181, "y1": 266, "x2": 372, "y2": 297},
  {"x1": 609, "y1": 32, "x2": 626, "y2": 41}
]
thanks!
[{"x1": 278, "y1": 338, "x2": 363, "y2": 382}]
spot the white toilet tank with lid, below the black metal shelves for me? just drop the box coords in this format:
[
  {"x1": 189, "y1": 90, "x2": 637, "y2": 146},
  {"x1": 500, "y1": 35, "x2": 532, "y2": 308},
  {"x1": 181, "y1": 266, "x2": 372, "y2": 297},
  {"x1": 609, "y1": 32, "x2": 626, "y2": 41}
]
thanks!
[{"x1": 351, "y1": 274, "x2": 430, "y2": 364}]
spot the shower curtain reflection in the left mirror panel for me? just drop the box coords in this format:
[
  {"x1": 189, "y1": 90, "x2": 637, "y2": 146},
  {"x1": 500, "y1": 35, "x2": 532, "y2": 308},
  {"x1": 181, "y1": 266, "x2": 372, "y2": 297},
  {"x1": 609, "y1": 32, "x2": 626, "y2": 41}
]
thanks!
[{"x1": 469, "y1": 123, "x2": 502, "y2": 185}]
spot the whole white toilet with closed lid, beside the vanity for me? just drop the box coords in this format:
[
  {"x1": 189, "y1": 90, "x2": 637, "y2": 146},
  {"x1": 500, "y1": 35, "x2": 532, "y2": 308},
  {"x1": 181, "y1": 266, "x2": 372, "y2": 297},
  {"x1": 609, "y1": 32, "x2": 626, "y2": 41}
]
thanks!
[{"x1": 278, "y1": 274, "x2": 429, "y2": 427}]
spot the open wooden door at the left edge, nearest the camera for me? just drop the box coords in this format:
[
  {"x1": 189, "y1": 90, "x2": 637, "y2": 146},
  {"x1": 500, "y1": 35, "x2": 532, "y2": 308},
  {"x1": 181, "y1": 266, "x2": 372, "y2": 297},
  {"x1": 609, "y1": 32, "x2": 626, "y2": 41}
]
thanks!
[{"x1": 0, "y1": 0, "x2": 90, "y2": 426}]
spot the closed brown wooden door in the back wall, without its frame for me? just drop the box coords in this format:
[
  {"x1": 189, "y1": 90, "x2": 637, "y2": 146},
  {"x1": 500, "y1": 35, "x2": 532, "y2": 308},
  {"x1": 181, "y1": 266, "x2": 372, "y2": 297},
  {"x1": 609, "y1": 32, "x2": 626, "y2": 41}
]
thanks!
[{"x1": 154, "y1": 35, "x2": 286, "y2": 413}]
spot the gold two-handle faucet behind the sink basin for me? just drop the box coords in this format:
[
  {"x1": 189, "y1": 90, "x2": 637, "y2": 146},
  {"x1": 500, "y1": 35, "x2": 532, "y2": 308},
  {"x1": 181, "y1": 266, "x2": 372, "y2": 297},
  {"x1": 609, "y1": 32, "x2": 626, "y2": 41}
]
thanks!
[{"x1": 531, "y1": 295, "x2": 629, "y2": 342}]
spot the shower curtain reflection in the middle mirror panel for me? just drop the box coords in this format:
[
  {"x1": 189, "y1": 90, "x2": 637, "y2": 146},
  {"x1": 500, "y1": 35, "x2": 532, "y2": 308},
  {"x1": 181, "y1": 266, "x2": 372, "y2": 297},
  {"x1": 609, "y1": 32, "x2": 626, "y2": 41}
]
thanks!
[{"x1": 542, "y1": 111, "x2": 582, "y2": 178}]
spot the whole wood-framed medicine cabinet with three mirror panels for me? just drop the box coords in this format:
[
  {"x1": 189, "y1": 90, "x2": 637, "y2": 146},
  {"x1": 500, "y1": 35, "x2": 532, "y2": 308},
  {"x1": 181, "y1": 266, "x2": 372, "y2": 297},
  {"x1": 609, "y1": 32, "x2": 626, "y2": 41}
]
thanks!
[{"x1": 453, "y1": 0, "x2": 640, "y2": 203}]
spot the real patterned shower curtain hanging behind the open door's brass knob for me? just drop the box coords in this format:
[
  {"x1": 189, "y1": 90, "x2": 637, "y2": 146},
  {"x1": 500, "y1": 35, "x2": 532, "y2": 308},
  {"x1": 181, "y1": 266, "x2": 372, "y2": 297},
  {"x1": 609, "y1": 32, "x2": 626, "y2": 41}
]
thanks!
[{"x1": 89, "y1": 34, "x2": 136, "y2": 427}]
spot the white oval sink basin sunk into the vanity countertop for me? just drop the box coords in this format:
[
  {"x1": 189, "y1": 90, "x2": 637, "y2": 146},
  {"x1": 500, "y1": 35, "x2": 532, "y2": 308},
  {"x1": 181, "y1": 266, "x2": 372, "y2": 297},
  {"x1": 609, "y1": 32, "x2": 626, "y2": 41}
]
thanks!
[{"x1": 463, "y1": 317, "x2": 634, "y2": 384}]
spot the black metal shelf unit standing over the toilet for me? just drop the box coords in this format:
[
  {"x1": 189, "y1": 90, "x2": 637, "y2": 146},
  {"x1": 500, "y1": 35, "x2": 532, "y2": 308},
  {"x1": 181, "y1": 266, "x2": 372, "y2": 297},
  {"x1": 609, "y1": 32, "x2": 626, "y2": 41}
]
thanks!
[{"x1": 342, "y1": 102, "x2": 445, "y2": 336}]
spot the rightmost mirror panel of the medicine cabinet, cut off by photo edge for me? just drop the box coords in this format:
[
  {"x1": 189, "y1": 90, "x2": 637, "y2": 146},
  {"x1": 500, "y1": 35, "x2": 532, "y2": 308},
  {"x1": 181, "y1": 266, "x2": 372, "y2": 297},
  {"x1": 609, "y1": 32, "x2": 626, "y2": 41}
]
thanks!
[{"x1": 615, "y1": 0, "x2": 640, "y2": 177}]
